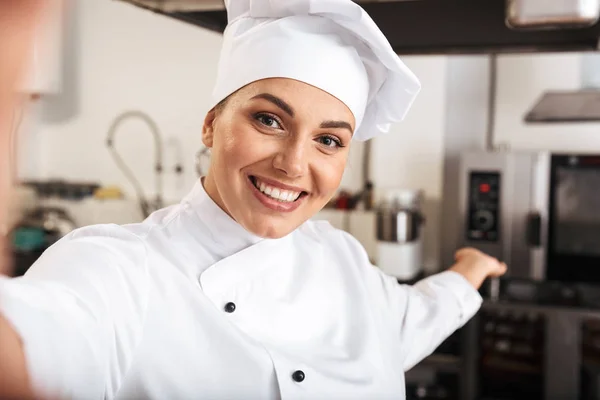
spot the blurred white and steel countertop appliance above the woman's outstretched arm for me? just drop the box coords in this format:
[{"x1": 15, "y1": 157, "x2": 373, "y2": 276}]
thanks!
[{"x1": 376, "y1": 190, "x2": 425, "y2": 281}]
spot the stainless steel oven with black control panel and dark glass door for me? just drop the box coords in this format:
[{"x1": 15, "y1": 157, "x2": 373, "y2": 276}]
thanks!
[{"x1": 458, "y1": 151, "x2": 600, "y2": 283}]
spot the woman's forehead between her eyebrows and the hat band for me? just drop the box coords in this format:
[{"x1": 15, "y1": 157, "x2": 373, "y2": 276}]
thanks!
[{"x1": 235, "y1": 78, "x2": 354, "y2": 126}]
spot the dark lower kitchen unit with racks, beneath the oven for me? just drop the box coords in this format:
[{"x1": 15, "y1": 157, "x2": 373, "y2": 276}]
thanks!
[{"x1": 463, "y1": 298, "x2": 600, "y2": 400}]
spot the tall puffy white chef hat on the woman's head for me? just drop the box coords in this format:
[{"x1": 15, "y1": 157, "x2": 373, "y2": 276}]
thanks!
[{"x1": 212, "y1": 0, "x2": 421, "y2": 140}]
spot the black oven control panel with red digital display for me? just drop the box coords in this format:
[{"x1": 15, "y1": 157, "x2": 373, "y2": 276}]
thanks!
[{"x1": 467, "y1": 171, "x2": 500, "y2": 242}]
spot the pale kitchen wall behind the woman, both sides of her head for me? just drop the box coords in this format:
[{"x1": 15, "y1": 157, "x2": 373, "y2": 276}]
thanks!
[{"x1": 20, "y1": 0, "x2": 600, "y2": 271}]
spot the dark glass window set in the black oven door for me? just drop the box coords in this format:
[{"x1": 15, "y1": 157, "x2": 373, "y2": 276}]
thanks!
[{"x1": 553, "y1": 167, "x2": 600, "y2": 256}]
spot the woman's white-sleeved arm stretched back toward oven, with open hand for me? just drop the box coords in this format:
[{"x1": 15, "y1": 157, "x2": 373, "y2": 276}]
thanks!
[{"x1": 342, "y1": 219, "x2": 506, "y2": 370}]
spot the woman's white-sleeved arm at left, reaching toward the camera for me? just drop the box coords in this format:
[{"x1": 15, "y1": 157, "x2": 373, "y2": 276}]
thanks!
[{"x1": 0, "y1": 225, "x2": 150, "y2": 399}]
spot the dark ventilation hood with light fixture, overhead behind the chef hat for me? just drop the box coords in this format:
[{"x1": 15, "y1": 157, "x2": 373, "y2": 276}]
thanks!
[{"x1": 115, "y1": 0, "x2": 600, "y2": 54}]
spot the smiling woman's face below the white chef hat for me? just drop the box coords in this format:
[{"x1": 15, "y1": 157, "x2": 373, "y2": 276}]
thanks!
[{"x1": 202, "y1": 78, "x2": 354, "y2": 238}]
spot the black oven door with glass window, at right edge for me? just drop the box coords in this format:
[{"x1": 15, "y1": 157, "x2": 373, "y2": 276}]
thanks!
[{"x1": 546, "y1": 154, "x2": 600, "y2": 283}]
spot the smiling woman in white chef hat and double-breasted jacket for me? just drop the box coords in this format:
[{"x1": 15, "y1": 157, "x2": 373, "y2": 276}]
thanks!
[{"x1": 0, "y1": 0, "x2": 505, "y2": 399}]
